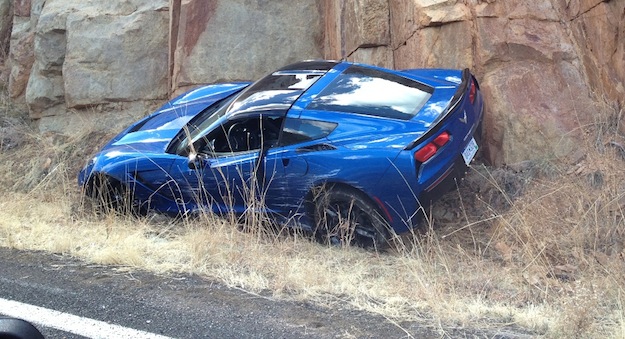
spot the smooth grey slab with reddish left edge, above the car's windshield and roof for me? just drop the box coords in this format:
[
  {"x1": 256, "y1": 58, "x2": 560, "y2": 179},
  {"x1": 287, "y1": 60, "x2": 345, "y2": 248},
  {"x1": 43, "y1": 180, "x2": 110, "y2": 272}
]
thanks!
[{"x1": 171, "y1": 0, "x2": 323, "y2": 90}]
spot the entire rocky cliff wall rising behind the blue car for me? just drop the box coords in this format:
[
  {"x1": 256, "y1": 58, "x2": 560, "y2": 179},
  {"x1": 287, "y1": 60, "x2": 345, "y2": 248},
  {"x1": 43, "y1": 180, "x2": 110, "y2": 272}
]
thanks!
[{"x1": 0, "y1": 0, "x2": 625, "y2": 164}]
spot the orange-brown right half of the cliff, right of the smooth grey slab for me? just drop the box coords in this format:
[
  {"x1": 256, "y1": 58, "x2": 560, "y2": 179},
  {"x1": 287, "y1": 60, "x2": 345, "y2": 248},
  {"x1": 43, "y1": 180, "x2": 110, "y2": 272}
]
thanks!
[{"x1": 325, "y1": 0, "x2": 625, "y2": 165}]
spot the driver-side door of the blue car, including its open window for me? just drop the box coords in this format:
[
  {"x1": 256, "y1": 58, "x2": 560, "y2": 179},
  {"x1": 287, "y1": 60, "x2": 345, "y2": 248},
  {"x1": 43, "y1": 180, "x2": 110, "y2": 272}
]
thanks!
[{"x1": 188, "y1": 110, "x2": 285, "y2": 213}]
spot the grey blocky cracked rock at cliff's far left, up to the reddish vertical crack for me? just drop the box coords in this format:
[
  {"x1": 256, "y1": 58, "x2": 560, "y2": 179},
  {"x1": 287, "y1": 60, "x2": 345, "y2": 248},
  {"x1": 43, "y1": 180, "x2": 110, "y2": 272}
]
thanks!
[{"x1": 1, "y1": 0, "x2": 169, "y2": 132}]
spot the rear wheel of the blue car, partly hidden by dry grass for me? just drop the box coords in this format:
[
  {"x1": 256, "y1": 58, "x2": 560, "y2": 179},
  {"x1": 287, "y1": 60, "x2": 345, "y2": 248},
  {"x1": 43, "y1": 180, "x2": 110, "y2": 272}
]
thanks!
[{"x1": 314, "y1": 186, "x2": 390, "y2": 250}]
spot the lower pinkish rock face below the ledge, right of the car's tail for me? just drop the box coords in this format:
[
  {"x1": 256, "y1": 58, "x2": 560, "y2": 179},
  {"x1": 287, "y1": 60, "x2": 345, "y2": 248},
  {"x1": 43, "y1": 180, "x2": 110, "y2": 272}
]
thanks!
[{"x1": 481, "y1": 59, "x2": 596, "y2": 165}]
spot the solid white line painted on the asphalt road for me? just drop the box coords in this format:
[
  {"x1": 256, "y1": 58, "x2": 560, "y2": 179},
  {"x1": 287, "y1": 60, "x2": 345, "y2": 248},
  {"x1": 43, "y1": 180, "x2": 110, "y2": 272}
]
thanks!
[{"x1": 0, "y1": 298, "x2": 169, "y2": 339}]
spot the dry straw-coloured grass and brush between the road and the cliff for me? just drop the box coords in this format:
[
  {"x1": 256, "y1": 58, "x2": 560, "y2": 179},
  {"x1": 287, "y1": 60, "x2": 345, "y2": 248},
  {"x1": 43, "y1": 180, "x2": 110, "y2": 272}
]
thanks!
[{"x1": 0, "y1": 91, "x2": 625, "y2": 337}]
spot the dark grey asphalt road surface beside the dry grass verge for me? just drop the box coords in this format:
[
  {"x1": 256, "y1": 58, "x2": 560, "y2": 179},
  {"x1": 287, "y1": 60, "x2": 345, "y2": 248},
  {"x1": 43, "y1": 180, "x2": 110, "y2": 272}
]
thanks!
[{"x1": 0, "y1": 248, "x2": 440, "y2": 338}]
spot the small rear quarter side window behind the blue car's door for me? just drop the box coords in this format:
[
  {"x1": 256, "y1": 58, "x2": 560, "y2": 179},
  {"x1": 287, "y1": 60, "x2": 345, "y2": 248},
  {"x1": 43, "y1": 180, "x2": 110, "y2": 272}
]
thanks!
[{"x1": 280, "y1": 118, "x2": 337, "y2": 146}]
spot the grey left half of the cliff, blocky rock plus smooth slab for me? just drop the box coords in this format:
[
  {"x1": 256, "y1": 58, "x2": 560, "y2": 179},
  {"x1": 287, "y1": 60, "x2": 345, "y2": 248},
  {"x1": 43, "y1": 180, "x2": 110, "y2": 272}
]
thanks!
[{"x1": 0, "y1": 0, "x2": 323, "y2": 133}]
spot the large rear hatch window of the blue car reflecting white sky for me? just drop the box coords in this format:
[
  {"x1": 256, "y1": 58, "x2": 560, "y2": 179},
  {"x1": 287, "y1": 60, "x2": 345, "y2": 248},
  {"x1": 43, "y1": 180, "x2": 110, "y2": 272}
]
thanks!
[{"x1": 307, "y1": 66, "x2": 433, "y2": 120}]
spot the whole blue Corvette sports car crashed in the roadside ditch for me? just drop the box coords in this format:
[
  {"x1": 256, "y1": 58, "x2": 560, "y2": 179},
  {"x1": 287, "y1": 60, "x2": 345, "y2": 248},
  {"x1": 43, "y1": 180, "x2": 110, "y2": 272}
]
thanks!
[{"x1": 78, "y1": 61, "x2": 483, "y2": 247}]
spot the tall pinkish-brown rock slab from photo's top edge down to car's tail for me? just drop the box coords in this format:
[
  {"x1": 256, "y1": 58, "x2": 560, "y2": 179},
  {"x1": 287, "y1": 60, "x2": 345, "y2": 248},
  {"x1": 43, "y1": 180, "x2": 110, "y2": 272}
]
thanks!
[{"x1": 474, "y1": 1, "x2": 596, "y2": 165}]
